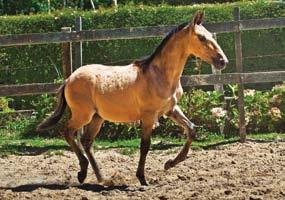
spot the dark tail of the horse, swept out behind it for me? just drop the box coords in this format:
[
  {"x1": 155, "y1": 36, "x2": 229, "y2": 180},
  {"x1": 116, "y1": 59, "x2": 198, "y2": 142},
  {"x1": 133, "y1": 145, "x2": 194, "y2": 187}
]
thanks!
[{"x1": 37, "y1": 84, "x2": 66, "y2": 131}]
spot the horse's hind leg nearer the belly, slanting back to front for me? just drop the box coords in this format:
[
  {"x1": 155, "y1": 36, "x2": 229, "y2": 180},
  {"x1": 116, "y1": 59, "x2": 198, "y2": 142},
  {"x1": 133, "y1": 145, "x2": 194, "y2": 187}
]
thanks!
[{"x1": 80, "y1": 114, "x2": 104, "y2": 182}]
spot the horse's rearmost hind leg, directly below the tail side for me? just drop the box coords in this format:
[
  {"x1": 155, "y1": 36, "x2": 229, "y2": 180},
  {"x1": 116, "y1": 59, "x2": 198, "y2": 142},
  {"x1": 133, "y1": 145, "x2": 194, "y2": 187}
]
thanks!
[{"x1": 63, "y1": 110, "x2": 93, "y2": 183}]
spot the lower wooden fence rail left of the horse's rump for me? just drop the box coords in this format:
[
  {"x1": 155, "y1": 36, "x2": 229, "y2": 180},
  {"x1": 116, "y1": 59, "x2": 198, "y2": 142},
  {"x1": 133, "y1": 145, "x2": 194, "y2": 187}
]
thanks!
[{"x1": 0, "y1": 83, "x2": 60, "y2": 97}]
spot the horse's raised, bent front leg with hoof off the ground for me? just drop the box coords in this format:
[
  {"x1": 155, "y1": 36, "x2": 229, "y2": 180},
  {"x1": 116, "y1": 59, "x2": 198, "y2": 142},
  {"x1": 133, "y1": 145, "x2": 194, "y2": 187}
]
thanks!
[{"x1": 164, "y1": 105, "x2": 195, "y2": 170}]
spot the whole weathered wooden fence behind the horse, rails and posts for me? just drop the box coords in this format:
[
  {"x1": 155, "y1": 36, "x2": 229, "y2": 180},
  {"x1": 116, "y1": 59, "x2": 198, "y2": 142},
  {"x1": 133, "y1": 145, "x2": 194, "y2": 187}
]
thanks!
[{"x1": 0, "y1": 8, "x2": 285, "y2": 142}]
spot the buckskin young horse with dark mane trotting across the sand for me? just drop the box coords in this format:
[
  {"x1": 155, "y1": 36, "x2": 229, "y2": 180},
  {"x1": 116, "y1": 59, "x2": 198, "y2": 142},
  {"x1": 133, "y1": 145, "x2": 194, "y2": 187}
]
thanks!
[{"x1": 38, "y1": 11, "x2": 228, "y2": 185}]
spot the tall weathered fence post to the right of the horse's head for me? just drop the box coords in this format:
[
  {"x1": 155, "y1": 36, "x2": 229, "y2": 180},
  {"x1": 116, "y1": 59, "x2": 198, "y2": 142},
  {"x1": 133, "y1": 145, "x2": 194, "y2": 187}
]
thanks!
[{"x1": 234, "y1": 7, "x2": 246, "y2": 142}]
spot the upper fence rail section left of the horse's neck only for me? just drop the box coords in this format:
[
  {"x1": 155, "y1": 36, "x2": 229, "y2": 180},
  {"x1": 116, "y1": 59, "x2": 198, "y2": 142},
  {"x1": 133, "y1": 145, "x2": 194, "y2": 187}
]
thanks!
[{"x1": 0, "y1": 26, "x2": 172, "y2": 46}]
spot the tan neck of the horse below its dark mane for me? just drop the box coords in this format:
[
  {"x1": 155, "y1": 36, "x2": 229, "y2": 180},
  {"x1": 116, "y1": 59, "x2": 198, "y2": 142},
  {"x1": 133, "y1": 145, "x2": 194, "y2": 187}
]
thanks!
[{"x1": 152, "y1": 33, "x2": 188, "y2": 88}]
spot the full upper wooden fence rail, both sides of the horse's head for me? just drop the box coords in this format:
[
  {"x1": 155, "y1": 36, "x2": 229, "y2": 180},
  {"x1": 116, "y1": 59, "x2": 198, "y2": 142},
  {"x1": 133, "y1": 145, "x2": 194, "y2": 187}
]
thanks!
[{"x1": 0, "y1": 17, "x2": 285, "y2": 47}]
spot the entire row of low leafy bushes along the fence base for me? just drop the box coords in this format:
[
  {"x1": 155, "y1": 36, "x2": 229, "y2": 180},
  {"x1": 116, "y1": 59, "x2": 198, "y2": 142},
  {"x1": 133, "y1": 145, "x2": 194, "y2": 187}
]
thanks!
[{"x1": 0, "y1": 84, "x2": 285, "y2": 141}]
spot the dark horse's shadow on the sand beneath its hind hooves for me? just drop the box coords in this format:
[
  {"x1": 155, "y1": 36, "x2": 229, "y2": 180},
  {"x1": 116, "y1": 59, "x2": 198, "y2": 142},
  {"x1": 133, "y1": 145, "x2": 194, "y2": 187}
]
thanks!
[{"x1": 0, "y1": 183, "x2": 131, "y2": 192}]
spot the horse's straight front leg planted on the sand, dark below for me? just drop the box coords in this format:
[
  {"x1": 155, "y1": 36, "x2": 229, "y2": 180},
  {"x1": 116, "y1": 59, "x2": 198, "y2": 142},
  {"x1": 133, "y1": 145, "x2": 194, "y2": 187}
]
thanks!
[{"x1": 136, "y1": 118, "x2": 155, "y2": 185}]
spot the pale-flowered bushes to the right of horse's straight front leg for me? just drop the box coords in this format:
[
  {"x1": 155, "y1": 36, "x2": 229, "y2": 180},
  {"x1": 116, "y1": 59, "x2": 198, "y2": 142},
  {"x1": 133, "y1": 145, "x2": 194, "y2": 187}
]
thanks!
[{"x1": 158, "y1": 84, "x2": 285, "y2": 136}]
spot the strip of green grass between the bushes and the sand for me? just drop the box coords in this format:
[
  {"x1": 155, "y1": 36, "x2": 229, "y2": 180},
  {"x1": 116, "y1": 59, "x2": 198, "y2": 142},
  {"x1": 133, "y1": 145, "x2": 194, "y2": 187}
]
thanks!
[{"x1": 0, "y1": 133, "x2": 285, "y2": 157}]
